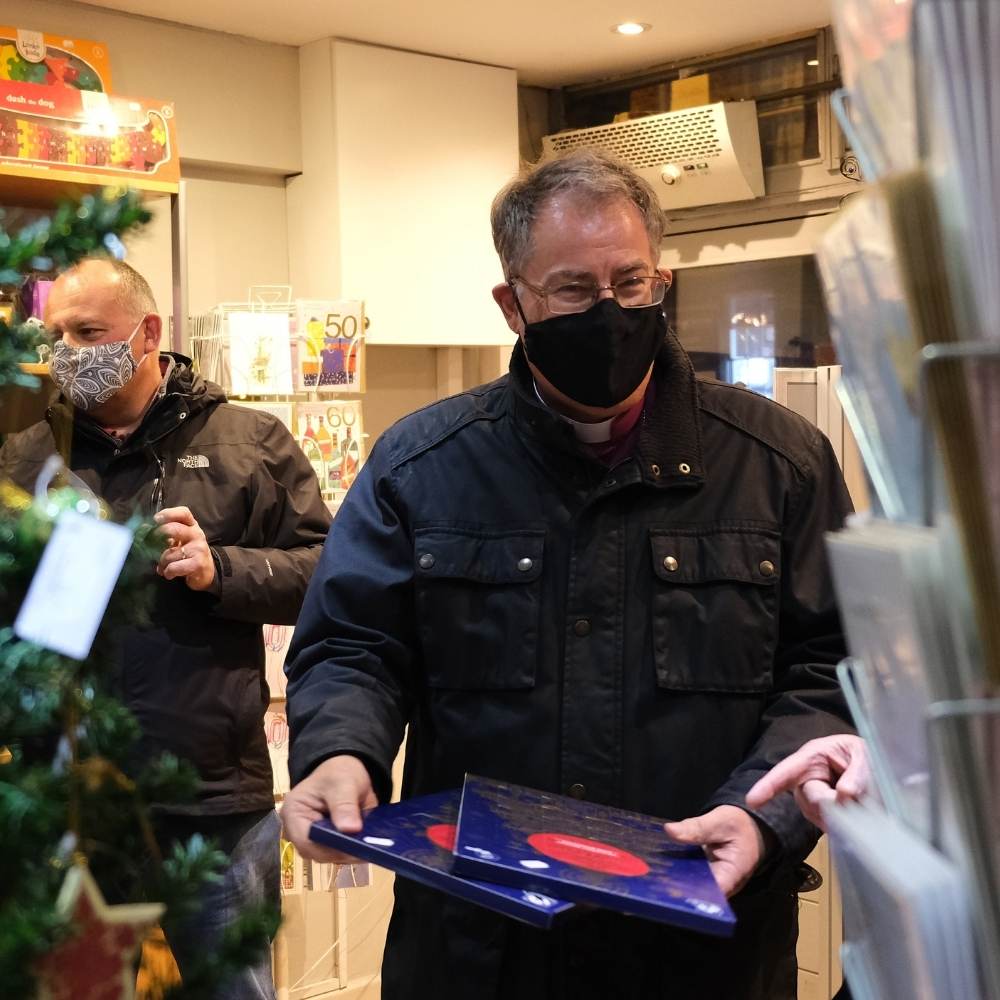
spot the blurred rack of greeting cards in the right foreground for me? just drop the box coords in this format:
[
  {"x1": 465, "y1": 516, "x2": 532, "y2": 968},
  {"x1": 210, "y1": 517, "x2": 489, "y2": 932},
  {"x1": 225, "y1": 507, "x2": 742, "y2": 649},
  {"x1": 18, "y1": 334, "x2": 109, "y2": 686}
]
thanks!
[{"x1": 818, "y1": 0, "x2": 1000, "y2": 1000}]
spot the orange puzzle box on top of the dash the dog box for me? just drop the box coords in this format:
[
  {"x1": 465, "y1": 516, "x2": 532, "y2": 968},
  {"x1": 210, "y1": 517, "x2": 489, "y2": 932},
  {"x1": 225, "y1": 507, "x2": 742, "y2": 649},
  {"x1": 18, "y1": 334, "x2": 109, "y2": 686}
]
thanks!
[{"x1": 0, "y1": 27, "x2": 111, "y2": 93}]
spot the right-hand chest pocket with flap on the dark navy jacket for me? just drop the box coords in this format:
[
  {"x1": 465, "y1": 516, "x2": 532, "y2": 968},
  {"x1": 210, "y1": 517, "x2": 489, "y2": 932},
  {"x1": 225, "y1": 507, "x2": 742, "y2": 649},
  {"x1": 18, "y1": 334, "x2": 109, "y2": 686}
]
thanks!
[{"x1": 649, "y1": 529, "x2": 781, "y2": 693}]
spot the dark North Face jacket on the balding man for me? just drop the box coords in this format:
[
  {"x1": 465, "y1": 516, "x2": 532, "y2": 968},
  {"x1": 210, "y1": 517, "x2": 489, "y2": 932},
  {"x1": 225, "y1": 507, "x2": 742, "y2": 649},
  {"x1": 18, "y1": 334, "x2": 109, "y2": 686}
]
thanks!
[{"x1": 0, "y1": 355, "x2": 330, "y2": 815}]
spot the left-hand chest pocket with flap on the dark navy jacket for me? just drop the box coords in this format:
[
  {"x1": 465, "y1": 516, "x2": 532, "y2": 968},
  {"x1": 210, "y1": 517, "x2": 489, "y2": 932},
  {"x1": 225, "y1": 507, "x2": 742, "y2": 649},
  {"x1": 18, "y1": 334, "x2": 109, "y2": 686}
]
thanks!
[{"x1": 414, "y1": 528, "x2": 545, "y2": 690}]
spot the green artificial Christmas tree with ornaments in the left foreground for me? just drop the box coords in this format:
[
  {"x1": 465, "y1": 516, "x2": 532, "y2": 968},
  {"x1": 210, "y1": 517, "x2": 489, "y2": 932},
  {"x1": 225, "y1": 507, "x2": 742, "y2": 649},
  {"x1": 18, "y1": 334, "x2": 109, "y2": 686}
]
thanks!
[{"x1": 0, "y1": 193, "x2": 277, "y2": 1000}]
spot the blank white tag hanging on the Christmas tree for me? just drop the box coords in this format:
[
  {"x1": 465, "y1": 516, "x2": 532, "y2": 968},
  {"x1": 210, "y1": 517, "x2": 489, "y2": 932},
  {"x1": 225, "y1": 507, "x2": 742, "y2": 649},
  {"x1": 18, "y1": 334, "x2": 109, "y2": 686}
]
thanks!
[{"x1": 14, "y1": 511, "x2": 132, "y2": 660}]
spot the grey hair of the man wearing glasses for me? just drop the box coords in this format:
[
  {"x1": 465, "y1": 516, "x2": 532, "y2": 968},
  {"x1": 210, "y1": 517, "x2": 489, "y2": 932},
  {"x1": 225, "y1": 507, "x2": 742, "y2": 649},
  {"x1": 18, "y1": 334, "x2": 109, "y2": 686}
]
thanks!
[{"x1": 490, "y1": 148, "x2": 665, "y2": 278}]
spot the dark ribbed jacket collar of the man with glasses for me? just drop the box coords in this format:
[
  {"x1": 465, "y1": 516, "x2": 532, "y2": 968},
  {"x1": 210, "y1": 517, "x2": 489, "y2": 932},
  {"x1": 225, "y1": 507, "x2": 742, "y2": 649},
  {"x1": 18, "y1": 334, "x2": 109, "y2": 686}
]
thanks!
[{"x1": 509, "y1": 331, "x2": 705, "y2": 487}]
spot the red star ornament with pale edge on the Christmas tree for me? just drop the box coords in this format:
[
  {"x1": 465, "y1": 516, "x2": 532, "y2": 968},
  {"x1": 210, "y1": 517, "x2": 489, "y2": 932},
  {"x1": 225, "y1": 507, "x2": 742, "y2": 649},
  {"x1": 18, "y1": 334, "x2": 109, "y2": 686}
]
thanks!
[{"x1": 38, "y1": 865, "x2": 164, "y2": 1000}]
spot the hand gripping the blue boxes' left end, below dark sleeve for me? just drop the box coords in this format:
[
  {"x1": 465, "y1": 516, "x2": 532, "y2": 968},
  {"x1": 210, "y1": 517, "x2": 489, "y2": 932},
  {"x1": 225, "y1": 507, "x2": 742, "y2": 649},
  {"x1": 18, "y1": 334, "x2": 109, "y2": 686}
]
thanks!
[{"x1": 281, "y1": 754, "x2": 378, "y2": 865}]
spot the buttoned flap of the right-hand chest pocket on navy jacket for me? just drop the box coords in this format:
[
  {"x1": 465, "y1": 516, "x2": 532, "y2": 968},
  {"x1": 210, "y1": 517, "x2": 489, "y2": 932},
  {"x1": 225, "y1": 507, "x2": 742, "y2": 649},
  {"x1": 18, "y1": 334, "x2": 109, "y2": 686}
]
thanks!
[{"x1": 649, "y1": 528, "x2": 781, "y2": 586}]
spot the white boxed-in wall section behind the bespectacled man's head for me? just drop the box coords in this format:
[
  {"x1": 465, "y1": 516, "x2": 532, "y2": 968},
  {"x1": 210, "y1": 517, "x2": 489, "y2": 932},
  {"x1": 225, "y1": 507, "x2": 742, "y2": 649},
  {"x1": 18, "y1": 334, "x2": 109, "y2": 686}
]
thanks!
[{"x1": 289, "y1": 40, "x2": 518, "y2": 346}]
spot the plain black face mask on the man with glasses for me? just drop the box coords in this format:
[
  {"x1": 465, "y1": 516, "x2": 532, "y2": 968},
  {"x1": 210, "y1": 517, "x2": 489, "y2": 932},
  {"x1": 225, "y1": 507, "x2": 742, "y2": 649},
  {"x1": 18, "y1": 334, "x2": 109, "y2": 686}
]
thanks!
[{"x1": 524, "y1": 299, "x2": 667, "y2": 409}]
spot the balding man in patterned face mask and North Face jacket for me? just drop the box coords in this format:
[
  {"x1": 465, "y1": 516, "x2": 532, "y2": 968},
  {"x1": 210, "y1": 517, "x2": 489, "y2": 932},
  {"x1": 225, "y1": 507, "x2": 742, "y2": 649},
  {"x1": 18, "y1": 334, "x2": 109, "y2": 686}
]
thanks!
[{"x1": 0, "y1": 259, "x2": 330, "y2": 1000}]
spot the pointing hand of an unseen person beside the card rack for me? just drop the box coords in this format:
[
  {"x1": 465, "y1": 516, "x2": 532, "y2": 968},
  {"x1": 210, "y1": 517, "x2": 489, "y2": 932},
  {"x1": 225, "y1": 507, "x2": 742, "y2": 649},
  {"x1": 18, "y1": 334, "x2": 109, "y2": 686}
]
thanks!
[{"x1": 747, "y1": 733, "x2": 869, "y2": 830}]
